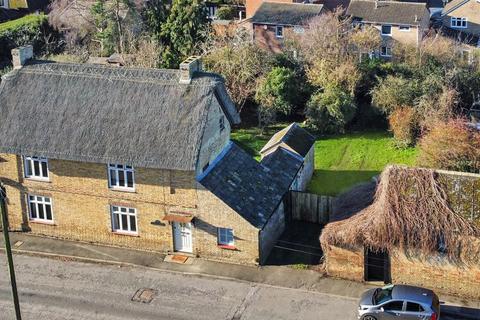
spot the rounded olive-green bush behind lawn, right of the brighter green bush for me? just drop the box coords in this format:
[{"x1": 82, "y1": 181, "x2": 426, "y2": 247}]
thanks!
[{"x1": 306, "y1": 87, "x2": 356, "y2": 133}]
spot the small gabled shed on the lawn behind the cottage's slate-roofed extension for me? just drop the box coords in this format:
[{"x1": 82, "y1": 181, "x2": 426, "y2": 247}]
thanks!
[{"x1": 260, "y1": 123, "x2": 315, "y2": 191}]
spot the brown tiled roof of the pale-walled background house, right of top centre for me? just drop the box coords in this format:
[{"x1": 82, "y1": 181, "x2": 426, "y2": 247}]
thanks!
[{"x1": 347, "y1": 0, "x2": 430, "y2": 26}]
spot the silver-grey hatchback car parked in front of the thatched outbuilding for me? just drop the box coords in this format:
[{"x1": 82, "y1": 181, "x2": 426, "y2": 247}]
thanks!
[{"x1": 358, "y1": 285, "x2": 440, "y2": 320}]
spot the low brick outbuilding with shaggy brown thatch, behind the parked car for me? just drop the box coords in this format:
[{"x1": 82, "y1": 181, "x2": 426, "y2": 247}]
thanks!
[{"x1": 320, "y1": 166, "x2": 480, "y2": 299}]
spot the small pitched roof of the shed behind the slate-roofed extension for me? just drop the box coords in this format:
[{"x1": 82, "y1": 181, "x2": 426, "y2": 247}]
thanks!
[{"x1": 260, "y1": 122, "x2": 315, "y2": 157}]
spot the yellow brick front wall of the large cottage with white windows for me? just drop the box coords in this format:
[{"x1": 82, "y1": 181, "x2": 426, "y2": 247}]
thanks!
[{"x1": 0, "y1": 154, "x2": 258, "y2": 264}]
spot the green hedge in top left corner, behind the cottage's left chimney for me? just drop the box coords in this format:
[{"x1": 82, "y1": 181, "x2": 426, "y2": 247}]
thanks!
[{"x1": 0, "y1": 13, "x2": 59, "y2": 63}]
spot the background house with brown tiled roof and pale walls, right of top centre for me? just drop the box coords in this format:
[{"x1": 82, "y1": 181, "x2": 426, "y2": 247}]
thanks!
[{"x1": 347, "y1": 0, "x2": 430, "y2": 58}]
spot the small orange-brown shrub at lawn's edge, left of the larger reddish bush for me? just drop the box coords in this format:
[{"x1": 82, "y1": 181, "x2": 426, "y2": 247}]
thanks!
[{"x1": 388, "y1": 107, "x2": 418, "y2": 148}]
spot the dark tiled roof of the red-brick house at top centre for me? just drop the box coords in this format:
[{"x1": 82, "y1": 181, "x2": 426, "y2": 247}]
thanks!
[{"x1": 251, "y1": 2, "x2": 323, "y2": 26}]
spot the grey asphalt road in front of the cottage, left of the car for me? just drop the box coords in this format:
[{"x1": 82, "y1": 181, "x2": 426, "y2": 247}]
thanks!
[{"x1": 0, "y1": 254, "x2": 357, "y2": 320}]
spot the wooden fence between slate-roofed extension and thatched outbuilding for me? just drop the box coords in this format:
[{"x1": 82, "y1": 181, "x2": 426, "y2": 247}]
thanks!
[{"x1": 290, "y1": 191, "x2": 335, "y2": 224}]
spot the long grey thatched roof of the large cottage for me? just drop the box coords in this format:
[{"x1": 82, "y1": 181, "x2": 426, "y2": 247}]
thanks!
[{"x1": 0, "y1": 62, "x2": 239, "y2": 170}]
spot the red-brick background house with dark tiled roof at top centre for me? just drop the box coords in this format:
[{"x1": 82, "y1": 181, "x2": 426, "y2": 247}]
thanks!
[{"x1": 249, "y1": 2, "x2": 324, "y2": 53}]
